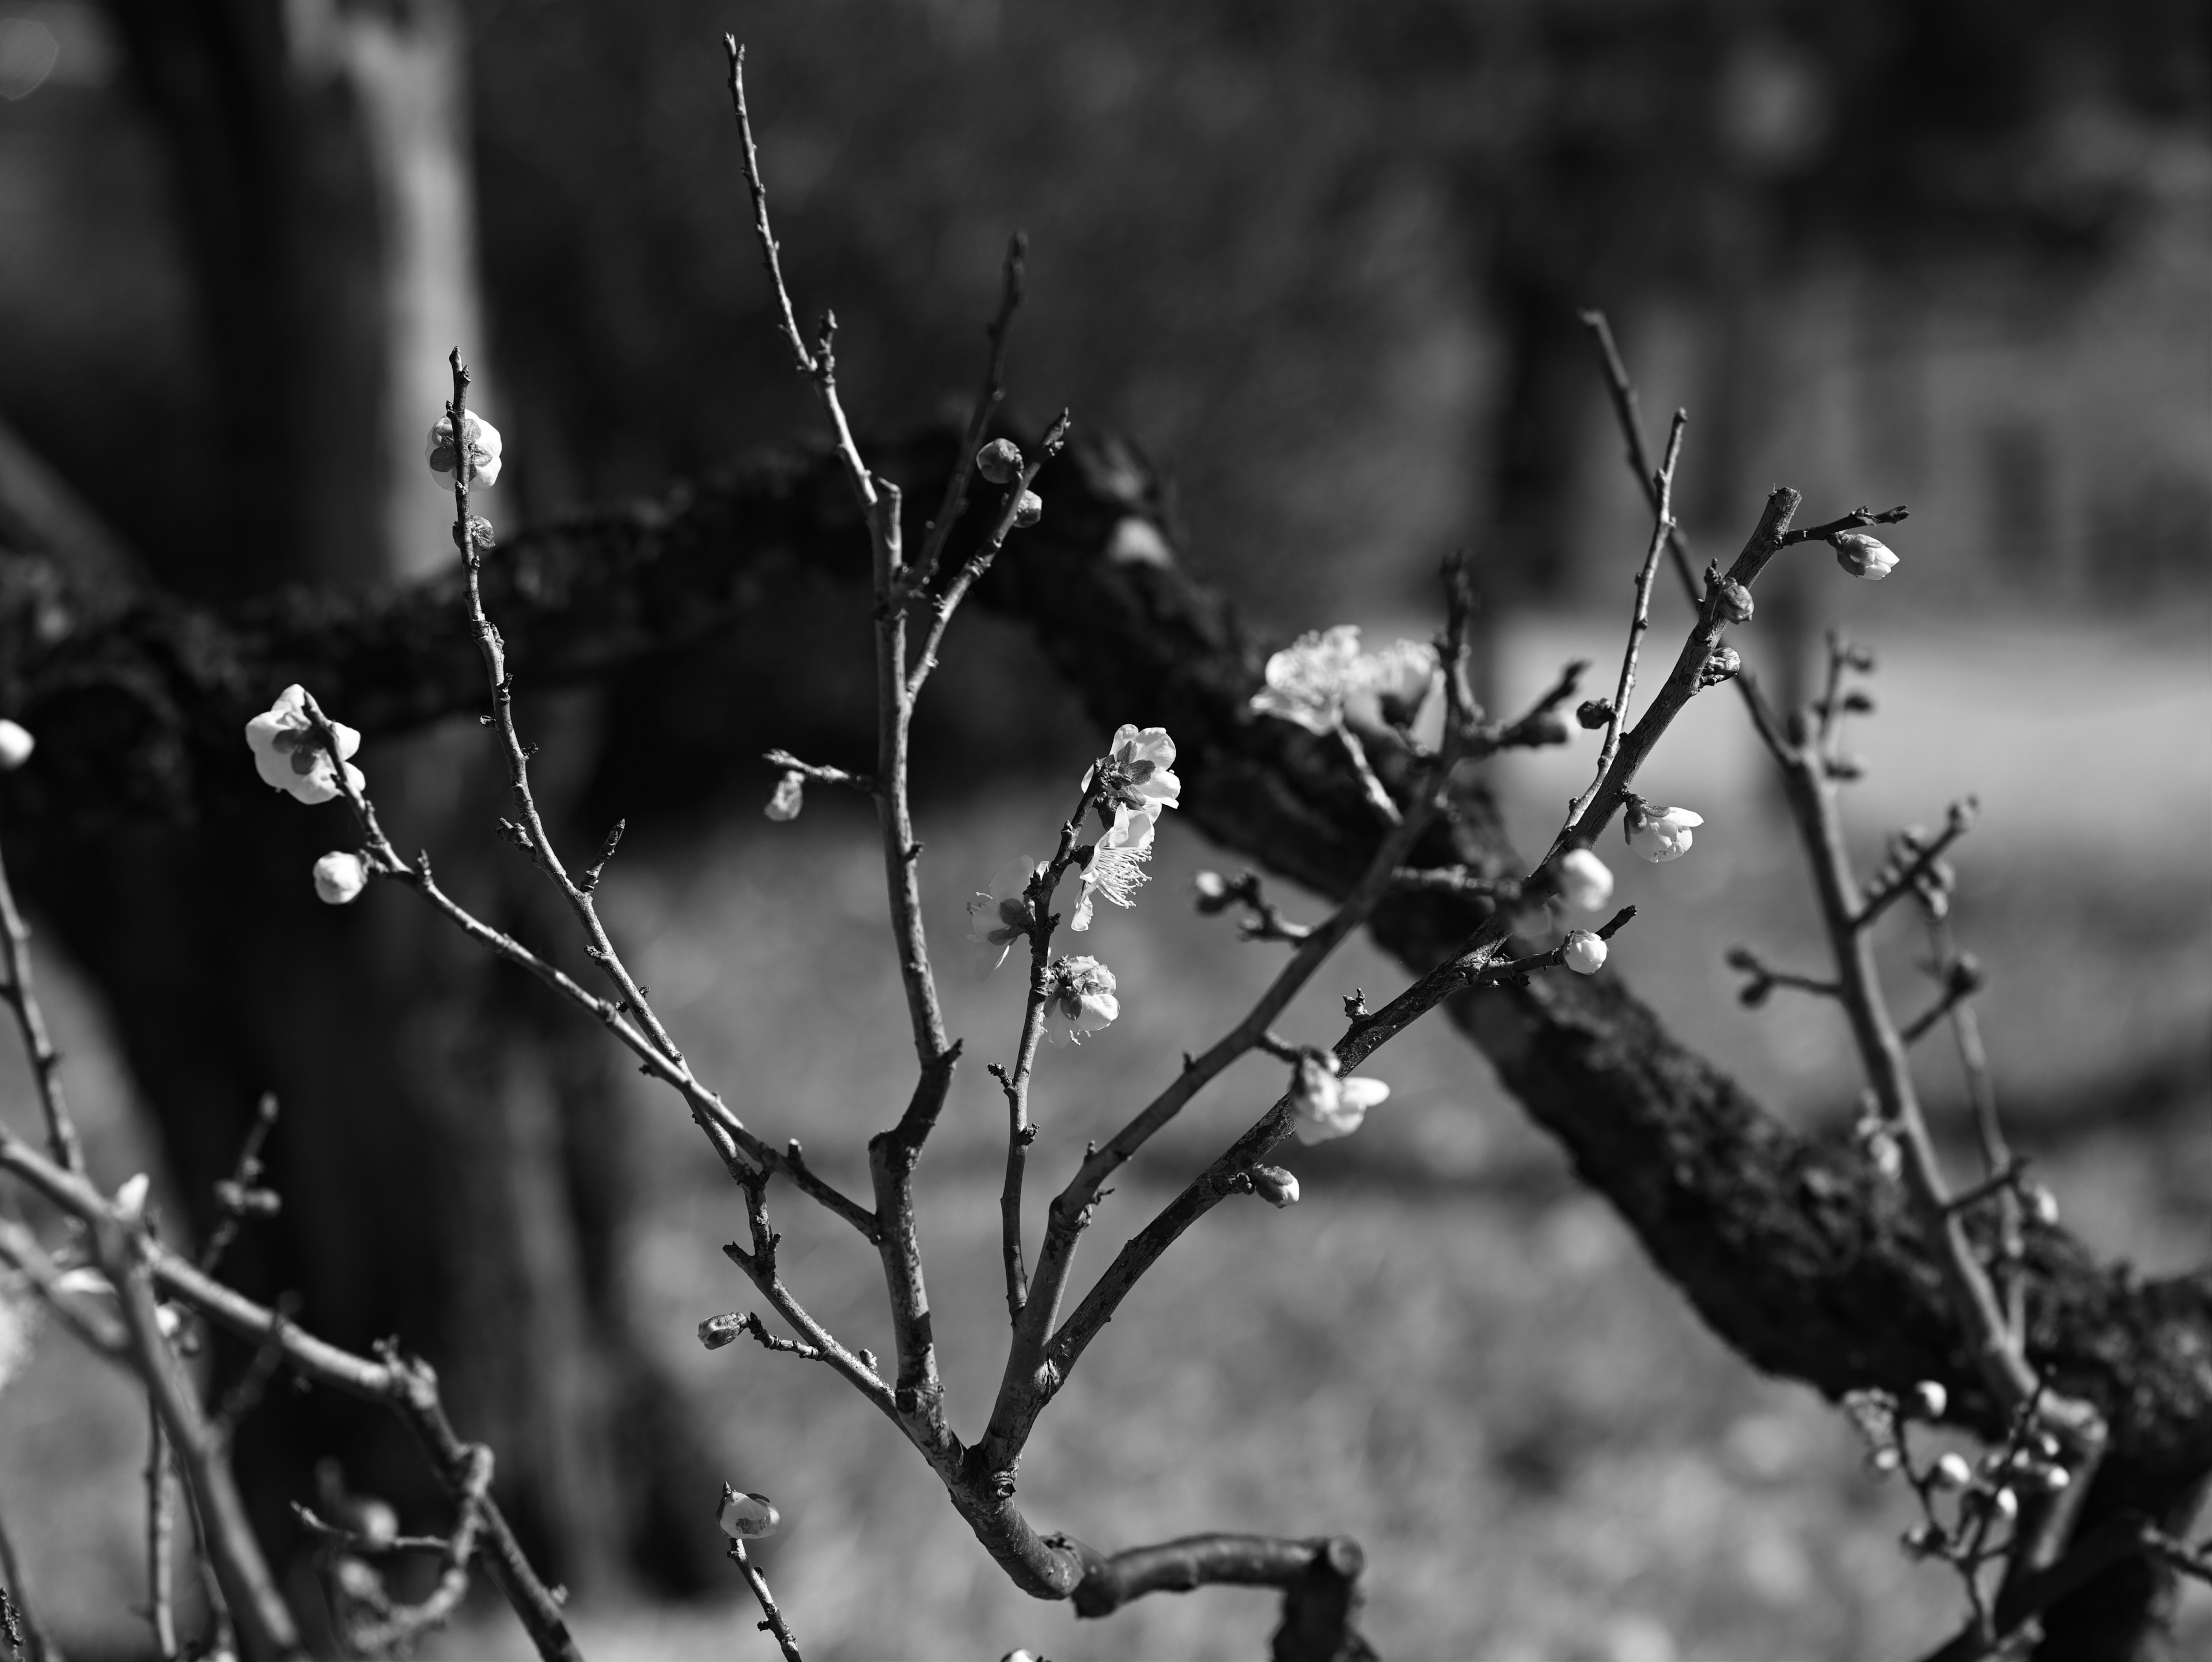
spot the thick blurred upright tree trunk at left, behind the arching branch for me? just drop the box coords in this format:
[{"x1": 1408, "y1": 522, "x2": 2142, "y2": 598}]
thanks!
[{"x1": 42, "y1": 0, "x2": 710, "y2": 1587}]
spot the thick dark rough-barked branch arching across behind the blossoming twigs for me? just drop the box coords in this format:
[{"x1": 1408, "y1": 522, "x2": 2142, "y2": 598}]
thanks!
[{"x1": 0, "y1": 425, "x2": 2212, "y2": 1662}]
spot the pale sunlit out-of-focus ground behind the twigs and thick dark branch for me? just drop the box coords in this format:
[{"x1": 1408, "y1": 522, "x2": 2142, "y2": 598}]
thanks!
[{"x1": 0, "y1": 615, "x2": 2212, "y2": 1662}]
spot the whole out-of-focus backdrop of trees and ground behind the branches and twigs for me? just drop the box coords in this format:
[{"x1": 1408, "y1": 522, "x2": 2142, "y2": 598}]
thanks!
[{"x1": 0, "y1": 0, "x2": 2212, "y2": 1662}]
